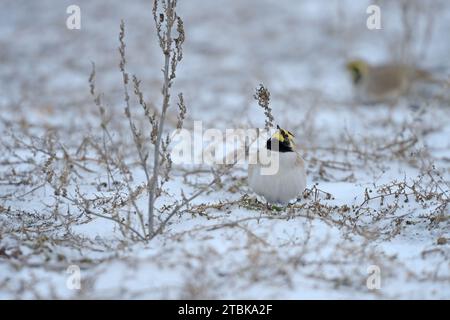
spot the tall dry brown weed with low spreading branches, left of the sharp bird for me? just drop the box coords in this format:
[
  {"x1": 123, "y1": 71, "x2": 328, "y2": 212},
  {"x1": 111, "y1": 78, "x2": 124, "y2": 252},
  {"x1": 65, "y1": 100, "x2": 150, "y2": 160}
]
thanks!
[{"x1": 84, "y1": 0, "x2": 226, "y2": 241}]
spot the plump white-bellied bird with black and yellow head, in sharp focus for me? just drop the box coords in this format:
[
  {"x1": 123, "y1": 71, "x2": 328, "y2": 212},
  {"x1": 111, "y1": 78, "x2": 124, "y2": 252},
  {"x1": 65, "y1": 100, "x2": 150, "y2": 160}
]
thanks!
[{"x1": 248, "y1": 126, "x2": 306, "y2": 205}]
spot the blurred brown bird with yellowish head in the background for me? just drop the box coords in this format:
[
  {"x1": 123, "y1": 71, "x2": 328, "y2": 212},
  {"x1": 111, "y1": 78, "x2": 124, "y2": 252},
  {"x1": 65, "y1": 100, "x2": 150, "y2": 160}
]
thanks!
[{"x1": 346, "y1": 59, "x2": 439, "y2": 104}]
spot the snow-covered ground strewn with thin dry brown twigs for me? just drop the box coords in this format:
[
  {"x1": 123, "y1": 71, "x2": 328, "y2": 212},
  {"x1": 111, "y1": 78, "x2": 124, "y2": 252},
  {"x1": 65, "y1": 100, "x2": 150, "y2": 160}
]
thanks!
[{"x1": 0, "y1": 0, "x2": 450, "y2": 299}]
